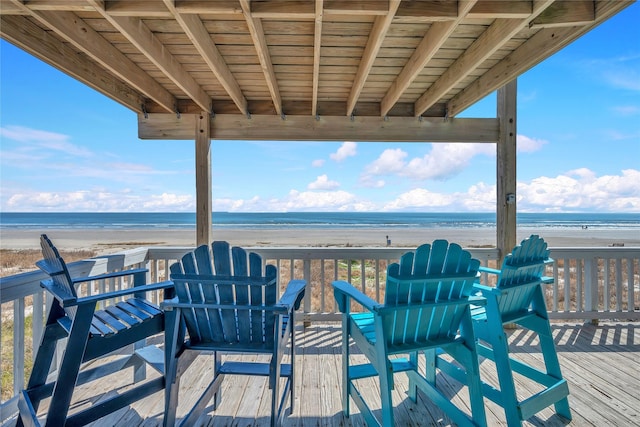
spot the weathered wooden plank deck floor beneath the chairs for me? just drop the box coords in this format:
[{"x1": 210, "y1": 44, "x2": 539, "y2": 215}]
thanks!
[{"x1": 28, "y1": 323, "x2": 640, "y2": 427}]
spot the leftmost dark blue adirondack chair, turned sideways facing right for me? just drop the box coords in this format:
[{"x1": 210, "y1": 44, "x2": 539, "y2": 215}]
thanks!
[{"x1": 17, "y1": 234, "x2": 173, "y2": 426}]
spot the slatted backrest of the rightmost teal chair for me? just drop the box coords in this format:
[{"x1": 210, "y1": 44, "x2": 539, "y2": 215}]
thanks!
[{"x1": 496, "y1": 235, "x2": 550, "y2": 316}]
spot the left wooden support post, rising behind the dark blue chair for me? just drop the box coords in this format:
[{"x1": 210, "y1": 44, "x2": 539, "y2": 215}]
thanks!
[{"x1": 195, "y1": 111, "x2": 212, "y2": 246}]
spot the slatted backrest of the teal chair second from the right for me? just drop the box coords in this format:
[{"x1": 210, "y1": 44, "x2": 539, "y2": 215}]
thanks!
[{"x1": 382, "y1": 240, "x2": 480, "y2": 346}]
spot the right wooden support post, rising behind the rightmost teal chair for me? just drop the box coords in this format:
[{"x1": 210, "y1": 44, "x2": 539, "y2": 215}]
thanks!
[{"x1": 496, "y1": 80, "x2": 517, "y2": 265}]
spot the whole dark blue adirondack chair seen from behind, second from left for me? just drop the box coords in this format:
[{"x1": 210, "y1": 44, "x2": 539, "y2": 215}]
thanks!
[{"x1": 162, "y1": 241, "x2": 305, "y2": 426}]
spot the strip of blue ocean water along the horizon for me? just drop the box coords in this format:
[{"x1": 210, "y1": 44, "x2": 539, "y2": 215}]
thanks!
[{"x1": 0, "y1": 212, "x2": 640, "y2": 232}]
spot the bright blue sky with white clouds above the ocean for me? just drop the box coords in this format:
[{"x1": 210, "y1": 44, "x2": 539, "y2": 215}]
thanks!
[{"x1": 0, "y1": 3, "x2": 640, "y2": 213}]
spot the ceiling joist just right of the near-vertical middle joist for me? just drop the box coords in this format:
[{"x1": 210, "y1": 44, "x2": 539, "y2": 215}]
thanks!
[{"x1": 346, "y1": 0, "x2": 400, "y2": 116}]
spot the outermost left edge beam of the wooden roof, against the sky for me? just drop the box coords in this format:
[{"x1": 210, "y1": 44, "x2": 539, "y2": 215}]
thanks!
[{"x1": 0, "y1": 16, "x2": 145, "y2": 112}]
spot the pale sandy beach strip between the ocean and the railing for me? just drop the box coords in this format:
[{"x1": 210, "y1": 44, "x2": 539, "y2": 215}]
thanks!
[{"x1": 0, "y1": 228, "x2": 640, "y2": 253}]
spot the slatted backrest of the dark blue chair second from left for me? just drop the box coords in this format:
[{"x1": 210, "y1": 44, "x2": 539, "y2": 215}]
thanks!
[{"x1": 170, "y1": 241, "x2": 278, "y2": 347}]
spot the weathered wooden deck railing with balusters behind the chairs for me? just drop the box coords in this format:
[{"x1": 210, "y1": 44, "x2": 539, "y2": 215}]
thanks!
[{"x1": 0, "y1": 247, "x2": 640, "y2": 423}]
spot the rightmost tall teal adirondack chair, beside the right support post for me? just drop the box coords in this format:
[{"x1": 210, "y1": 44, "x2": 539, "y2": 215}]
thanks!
[{"x1": 464, "y1": 235, "x2": 571, "y2": 426}]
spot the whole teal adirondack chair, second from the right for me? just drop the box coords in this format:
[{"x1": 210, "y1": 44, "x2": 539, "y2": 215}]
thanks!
[{"x1": 333, "y1": 240, "x2": 486, "y2": 426}]
